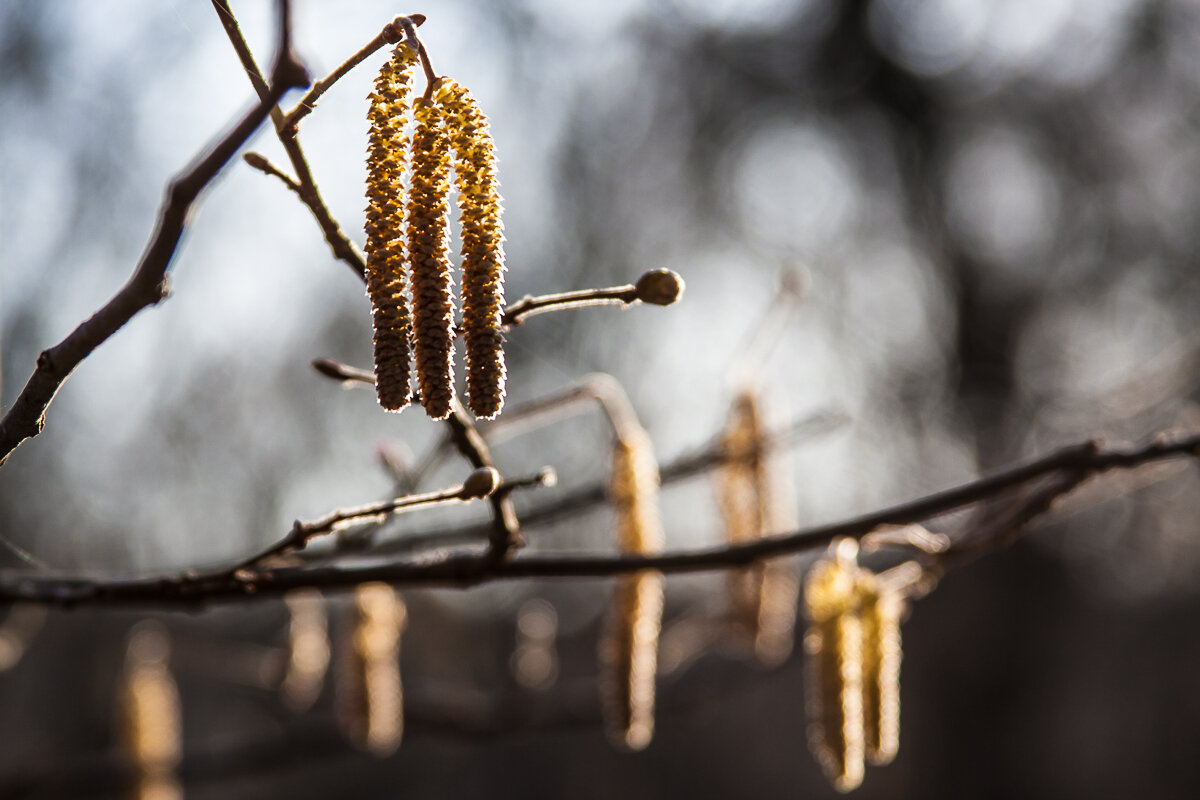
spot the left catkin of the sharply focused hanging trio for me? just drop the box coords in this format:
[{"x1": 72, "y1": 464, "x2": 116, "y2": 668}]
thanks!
[{"x1": 365, "y1": 43, "x2": 416, "y2": 411}]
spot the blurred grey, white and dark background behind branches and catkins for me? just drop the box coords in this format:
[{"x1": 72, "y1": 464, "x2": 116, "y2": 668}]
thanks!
[{"x1": 0, "y1": 0, "x2": 1200, "y2": 798}]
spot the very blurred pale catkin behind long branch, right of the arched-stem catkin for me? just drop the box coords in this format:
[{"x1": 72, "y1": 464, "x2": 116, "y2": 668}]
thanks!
[{"x1": 716, "y1": 391, "x2": 799, "y2": 666}]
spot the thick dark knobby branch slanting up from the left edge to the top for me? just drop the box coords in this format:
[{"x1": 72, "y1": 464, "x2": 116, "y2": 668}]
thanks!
[{"x1": 0, "y1": 0, "x2": 308, "y2": 464}]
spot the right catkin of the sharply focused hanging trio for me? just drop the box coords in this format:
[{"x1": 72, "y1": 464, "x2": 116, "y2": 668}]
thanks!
[{"x1": 438, "y1": 79, "x2": 505, "y2": 419}]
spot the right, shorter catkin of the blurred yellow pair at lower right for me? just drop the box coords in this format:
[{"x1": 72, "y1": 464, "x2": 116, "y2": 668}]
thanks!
[{"x1": 858, "y1": 573, "x2": 905, "y2": 765}]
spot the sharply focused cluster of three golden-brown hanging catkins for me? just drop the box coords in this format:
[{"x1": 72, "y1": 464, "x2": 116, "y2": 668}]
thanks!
[{"x1": 366, "y1": 42, "x2": 505, "y2": 420}]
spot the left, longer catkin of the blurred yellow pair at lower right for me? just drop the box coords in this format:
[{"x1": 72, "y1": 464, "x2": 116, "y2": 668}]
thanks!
[{"x1": 804, "y1": 540, "x2": 865, "y2": 792}]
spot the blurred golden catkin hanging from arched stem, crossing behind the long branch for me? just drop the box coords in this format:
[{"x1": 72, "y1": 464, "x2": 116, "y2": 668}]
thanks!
[{"x1": 600, "y1": 428, "x2": 662, "y2": 750}]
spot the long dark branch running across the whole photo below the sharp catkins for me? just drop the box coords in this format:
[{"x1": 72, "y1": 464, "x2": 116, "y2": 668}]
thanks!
[{"x1": 0, "y1": 433, "x2": 1200, "y2": 606}]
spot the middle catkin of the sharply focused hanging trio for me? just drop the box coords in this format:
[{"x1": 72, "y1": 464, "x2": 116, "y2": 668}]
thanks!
[{"x1": 406, "y1": 92, "x2": 454, "y2": 420}]
